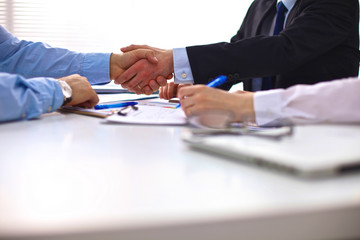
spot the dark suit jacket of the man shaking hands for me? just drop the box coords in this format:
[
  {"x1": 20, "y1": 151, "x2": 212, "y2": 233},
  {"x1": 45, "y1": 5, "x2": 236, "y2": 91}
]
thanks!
[{"x1": 186, "y1": 0, "x2": 359, "y2": 91}]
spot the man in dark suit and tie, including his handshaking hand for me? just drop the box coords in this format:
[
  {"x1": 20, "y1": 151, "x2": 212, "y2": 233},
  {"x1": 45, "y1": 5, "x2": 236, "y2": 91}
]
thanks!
[{"x1": 115, "y1": 0, "x2": 359, "y2": 96}]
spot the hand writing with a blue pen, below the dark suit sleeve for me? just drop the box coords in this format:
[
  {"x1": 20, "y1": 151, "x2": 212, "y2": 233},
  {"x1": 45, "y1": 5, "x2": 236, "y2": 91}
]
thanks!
[{"x1": 178, "y1": 84, "x2": 255, "y2": 122}]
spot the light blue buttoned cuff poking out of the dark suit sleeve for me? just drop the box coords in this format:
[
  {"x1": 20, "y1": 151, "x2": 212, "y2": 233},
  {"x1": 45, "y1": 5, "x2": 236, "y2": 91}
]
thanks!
[{"x1": 173, "y1": 48, "x2": 194, "y2": 84}]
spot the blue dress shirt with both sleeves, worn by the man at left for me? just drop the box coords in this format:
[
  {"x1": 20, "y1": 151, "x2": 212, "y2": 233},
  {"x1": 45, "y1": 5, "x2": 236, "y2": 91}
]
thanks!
[{"x1": 0, "y1": 26, "x2": 111, "y2": 122}]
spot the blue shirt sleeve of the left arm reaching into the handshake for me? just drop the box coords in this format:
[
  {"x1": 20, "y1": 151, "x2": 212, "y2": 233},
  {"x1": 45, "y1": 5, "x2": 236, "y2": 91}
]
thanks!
[{"x1": 0, "y1": 26, "x2": 111, "y2": 84}]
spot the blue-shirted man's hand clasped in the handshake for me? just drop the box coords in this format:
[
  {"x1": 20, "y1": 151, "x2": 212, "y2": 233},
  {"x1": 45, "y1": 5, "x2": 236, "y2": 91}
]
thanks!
[{"x1": 110, "y1": 49, "x2": 158, "y2": 80}]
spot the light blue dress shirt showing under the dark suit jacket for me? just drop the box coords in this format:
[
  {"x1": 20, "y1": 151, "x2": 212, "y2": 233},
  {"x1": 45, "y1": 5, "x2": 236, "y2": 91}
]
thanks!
[{"x1": 173, "y1": 0, "x2": 296, "y2": 87}]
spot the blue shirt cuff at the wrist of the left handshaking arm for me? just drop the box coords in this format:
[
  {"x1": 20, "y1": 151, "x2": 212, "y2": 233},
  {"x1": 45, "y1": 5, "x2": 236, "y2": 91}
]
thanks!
[{"x1": 83, "y1": 53, "x2": 111, "y2": 85}]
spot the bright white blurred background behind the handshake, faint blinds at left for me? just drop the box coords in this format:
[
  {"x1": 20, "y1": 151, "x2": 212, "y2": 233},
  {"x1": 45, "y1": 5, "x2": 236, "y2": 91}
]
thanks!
[{"x1": 0, "y1": 0, "x2": 252, "y2": 52}]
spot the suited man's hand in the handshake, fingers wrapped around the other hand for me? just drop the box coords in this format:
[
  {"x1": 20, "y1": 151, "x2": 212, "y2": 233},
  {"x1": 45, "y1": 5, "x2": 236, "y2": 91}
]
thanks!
[{"x1": 115, "y1": 45, "x2": 174, "y2": 94}]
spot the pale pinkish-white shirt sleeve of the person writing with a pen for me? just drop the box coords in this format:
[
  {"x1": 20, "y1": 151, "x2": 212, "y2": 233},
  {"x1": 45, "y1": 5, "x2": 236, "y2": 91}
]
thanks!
[{"x1": 254, "y1": 78, "x2": 360, "y2": 126}]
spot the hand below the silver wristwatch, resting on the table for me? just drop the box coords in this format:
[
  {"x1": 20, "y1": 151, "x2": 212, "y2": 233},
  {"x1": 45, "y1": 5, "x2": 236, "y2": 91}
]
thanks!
[{"x1": 58, "y1": 74, "x2": 99, "y2": 108}]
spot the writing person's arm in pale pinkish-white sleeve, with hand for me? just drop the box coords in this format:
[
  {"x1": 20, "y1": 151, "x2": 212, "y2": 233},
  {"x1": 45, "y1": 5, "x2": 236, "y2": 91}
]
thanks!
[{"x1": 160, "y1": 78, "x2": 360, "y2": 126}]
